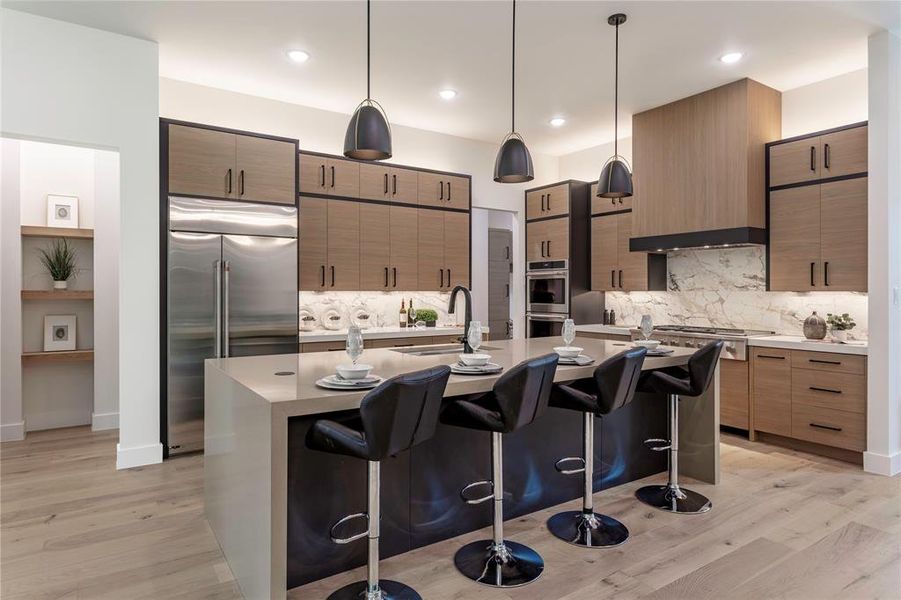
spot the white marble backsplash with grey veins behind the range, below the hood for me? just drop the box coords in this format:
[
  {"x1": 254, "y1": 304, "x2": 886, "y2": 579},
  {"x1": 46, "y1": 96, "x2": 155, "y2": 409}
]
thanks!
[{"x1": 605, "y1": 246, "x2": 868, "y2": 339}]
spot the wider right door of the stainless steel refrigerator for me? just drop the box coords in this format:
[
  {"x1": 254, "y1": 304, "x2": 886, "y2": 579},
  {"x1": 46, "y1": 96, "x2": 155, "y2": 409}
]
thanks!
[{"x1": 222, "y1": 235, "x2": 298, "y2": 356}]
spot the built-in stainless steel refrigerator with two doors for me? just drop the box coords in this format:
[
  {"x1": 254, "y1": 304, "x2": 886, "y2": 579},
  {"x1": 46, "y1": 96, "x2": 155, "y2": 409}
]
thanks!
[{"x1": 163, "y1": 197, "x2": 298, "y2": 454}]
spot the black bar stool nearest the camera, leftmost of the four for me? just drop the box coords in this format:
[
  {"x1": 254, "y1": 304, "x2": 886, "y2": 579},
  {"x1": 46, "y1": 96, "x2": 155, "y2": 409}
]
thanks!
[{"x1": 306, "y1": 366, "x2": 450, "y2": 600}]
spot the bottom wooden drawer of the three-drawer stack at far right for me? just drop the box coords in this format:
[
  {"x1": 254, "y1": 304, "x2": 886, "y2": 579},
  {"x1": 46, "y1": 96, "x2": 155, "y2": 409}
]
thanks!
[{"x1": 791, "y1": 402, "x2": 867, "y2": 452}]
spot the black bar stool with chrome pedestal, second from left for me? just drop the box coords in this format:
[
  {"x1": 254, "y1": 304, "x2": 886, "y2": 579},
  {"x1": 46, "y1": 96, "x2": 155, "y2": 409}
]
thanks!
[{"x1": 441, "y1": 354, "x2": 558, "y2": 588}]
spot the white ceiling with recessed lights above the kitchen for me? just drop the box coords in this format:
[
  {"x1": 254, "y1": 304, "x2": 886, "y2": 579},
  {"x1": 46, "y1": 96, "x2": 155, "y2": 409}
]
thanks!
[{"x1": 3, "y1": 0, "x2": 901, "y2": 154}]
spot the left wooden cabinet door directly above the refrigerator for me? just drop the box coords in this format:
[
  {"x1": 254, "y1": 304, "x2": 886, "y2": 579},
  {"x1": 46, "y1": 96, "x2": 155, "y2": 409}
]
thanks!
[{"x1": 169, "y1": 125, "x2": 238, "y2": 198}]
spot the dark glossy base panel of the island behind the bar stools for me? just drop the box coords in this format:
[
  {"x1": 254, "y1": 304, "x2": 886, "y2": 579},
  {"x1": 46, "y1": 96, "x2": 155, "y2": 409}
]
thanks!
[{"x1": 286, "y1": 394, "x2": 667, "y2": 589}]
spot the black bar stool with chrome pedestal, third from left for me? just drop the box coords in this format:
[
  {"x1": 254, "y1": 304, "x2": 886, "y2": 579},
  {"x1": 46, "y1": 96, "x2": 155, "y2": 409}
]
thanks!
[{"x1": 547, "y1": 348, "x2": 648, "y2": 548}]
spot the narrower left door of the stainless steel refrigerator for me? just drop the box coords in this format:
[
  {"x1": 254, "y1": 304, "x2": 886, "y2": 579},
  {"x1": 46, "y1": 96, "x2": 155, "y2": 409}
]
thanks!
[{"x1": 166, "y1": 232, "x2": 222, "y2": 454}]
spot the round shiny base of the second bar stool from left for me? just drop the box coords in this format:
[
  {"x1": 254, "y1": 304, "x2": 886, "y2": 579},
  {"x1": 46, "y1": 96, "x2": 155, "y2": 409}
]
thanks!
[{"x1": 454, "y1": 540, "x2": 544, "y2": 588}]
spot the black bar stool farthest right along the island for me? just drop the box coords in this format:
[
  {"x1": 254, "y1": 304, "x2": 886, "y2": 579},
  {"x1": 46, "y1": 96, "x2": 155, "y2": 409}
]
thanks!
[{"x1": 635, "y1": 340, "x2": 723, "y2": 515}]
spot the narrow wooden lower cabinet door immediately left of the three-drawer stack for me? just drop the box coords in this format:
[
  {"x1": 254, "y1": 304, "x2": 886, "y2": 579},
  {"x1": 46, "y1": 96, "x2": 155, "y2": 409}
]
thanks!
[{"x1": 751, "y1": 348, "x2": 792, "y2": 436}]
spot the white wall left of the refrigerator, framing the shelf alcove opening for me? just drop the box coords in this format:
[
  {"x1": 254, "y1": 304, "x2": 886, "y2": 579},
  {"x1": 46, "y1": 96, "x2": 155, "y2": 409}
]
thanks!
[{"x1": 0, "y1": 9, "x2": 162, "y2": 468}]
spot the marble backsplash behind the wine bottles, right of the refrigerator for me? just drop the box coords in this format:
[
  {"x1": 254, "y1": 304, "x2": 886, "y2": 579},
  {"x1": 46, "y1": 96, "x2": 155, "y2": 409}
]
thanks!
[{"x1": 298, "y1": 291, "x2": 463, "y2": 331}]
